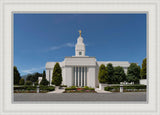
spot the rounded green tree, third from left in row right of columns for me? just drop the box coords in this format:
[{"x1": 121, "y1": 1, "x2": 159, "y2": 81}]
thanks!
[{"x1": 114, "y1": 66, "x2": 126, "y2": 84}]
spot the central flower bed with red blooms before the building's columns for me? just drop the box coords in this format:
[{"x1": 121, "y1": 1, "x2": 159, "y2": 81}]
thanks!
[{"x1": 64, "y1": 86, "x2": 96, "y2": 93}]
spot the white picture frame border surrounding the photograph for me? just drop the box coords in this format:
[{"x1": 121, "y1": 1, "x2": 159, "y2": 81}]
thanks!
[{"x1": 0, "y1": 0, "x2": 160, "y2": 115}]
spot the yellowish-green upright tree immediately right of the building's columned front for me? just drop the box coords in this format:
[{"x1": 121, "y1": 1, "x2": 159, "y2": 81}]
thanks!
[{"x1": 98, "y1": 64, "x2": 107, "y2": 83}]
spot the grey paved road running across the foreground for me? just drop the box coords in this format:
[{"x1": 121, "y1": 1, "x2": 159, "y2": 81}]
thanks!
[{"x1": 14, "y1": 92, "x2": 146, "y2": 102}]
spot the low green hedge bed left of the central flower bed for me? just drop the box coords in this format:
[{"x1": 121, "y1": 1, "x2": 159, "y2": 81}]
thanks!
[{"x1": 14, "y1": 85, "x2": 55, "y2": 93}]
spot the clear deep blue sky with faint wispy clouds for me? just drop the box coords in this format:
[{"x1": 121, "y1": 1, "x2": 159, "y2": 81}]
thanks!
[{"x1": 14, "y1": 14, "x2": 146, "y2": 75}]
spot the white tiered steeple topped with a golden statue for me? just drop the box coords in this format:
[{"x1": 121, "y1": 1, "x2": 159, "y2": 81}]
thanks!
[{"x1": 75, "y1": 30, "x2": 85, "y2": 56}]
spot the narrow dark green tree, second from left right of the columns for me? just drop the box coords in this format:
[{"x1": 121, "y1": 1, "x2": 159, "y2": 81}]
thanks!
[{"x1": 106, "y1": 63, "x2": 115, "y2": 83}]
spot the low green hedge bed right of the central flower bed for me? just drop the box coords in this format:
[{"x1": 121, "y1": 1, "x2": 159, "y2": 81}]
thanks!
[{"x1": 104, "y1": 85, "x2": 146, "y2": 92}]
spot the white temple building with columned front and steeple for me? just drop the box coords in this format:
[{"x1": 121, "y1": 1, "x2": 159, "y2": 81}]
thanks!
[{"x1": 46, "y1": 31, "x2": 130, "y2": 88}]
